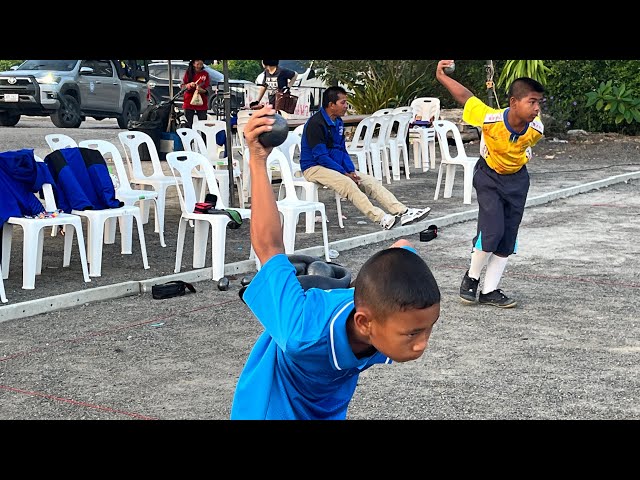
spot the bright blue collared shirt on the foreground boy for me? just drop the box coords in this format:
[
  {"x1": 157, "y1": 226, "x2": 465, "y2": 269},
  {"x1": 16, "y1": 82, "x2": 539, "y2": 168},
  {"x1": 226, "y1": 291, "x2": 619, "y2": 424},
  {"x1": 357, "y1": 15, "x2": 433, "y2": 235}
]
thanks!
[{"x1": 231, "y1": 254, "x2": 391, "y2": 420}]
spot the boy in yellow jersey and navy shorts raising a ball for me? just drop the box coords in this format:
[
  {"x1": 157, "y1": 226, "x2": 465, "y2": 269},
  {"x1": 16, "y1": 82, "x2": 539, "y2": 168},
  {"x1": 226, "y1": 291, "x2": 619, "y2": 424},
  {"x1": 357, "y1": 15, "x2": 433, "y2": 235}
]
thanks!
[{"x1": 436, "y1": 60, "x2": 544, "y2": 308}]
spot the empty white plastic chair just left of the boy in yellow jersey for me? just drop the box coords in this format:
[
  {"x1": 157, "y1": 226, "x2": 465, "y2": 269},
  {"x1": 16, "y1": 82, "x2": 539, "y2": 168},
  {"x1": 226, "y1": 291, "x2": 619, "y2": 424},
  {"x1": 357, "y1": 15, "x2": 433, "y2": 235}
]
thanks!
[{"x1": 433, "y1": 120, "x2": 480, "y2": 205}]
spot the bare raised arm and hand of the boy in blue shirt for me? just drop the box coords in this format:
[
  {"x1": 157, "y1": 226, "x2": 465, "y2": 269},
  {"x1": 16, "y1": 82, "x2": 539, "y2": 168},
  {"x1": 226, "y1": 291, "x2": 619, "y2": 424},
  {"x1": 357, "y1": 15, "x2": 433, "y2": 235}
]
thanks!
[{"x1": 244, "y1": 105, "x2": 284, "y2": 265}]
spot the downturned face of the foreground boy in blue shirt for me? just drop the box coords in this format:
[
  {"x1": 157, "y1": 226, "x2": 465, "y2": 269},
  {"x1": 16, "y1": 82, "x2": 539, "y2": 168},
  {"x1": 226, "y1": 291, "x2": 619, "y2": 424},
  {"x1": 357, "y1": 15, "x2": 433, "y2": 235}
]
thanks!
[{"x1": 368, "y1": 303, "x2": 440, "y2": 362}]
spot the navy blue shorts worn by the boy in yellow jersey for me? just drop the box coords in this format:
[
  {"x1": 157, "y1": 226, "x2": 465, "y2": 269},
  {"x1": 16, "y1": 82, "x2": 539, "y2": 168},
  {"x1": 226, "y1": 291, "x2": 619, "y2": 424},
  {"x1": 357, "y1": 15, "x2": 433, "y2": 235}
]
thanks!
[{"x1": 473, "y1": 157, "x2": 529, "y2": 257}]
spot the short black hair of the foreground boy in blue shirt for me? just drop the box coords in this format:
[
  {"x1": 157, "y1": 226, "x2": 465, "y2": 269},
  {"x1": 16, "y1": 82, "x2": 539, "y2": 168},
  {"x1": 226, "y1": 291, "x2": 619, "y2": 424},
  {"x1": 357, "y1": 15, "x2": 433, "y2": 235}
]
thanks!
[{"x1": 353, "y1": 247, "x2": 440, "y2": 321}]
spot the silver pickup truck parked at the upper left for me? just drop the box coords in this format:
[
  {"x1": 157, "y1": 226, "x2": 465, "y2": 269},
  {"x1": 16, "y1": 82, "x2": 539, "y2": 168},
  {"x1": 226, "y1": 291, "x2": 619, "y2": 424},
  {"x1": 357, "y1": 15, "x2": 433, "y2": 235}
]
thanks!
[{"x1": 0, "y1": 60, "x2": 149, "y2": 128}]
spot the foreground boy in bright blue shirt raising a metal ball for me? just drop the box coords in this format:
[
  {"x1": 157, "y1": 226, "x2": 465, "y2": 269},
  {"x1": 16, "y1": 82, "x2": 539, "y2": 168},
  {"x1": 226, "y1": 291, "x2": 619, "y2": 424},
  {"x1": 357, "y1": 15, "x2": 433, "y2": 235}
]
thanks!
[{"x1": 231, "y1": 105, "x2": 440, "y2": 420}]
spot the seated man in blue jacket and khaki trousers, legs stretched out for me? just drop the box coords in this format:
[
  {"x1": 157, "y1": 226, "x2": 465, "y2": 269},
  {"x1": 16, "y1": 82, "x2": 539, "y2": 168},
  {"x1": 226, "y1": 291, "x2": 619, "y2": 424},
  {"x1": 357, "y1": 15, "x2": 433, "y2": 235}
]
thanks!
[{"x1": 300, "y1": 86, "x2": 431, "y2": 230}]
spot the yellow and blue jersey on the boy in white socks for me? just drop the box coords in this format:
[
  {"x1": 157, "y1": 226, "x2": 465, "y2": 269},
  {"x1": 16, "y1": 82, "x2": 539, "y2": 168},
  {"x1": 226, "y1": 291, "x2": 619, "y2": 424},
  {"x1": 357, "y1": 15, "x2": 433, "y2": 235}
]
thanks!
[{"x1": 462, "y1": 97, "x2": 544, "y2": 175}]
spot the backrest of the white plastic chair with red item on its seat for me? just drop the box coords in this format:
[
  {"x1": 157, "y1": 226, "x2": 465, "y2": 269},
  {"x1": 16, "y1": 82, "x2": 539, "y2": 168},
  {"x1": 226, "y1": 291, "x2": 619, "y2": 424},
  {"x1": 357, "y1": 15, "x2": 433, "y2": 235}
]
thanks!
[{"x1": 166, "y1": 151, "x2": 227, "y2": 213}]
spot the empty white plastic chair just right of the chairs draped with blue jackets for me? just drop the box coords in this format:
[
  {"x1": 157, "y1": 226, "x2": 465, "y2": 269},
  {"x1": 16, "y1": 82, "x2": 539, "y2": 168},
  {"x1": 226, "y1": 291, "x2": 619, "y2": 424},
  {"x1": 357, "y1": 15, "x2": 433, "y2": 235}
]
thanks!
[{"x1": 78, "y1": 140, "x2": 167, "y2": 248}]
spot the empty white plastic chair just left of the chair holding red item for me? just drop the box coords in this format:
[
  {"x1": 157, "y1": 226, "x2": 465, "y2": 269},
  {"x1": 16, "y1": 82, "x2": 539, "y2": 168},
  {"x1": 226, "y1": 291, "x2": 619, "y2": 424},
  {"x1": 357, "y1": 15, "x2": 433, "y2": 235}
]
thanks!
[{"x1": 118, "y1": 130, "x2": 181, "y2": 240}]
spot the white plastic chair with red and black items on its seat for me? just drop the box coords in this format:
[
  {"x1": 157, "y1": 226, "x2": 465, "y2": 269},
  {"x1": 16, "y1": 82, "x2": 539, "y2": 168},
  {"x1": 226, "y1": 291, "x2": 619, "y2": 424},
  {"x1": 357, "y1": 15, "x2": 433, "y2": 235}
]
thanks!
[{"x1": 166, "y1": 151, "x2": 253, "y2": 280}]
